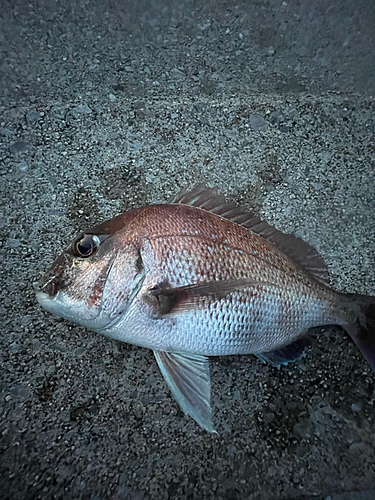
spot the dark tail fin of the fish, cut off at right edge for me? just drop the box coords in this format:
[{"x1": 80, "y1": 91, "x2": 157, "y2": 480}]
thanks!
[{"x1": 342, "y1": 294, "x2": 375, "y2": 371}]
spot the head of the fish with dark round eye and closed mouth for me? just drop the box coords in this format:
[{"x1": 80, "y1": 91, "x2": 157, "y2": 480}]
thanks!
[{"x1": 34, "y1": 219, "x2": 144, "y2": 333}]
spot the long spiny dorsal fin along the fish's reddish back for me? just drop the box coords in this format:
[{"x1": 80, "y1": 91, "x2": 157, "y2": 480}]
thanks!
[{"x1": 170, "y1": 184, "x2": 329, "y2": 286}]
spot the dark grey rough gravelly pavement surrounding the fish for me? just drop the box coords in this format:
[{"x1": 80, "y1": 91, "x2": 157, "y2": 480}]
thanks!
[{"x1": 0, "y1": 0, "x2": 375, "y2": 500}]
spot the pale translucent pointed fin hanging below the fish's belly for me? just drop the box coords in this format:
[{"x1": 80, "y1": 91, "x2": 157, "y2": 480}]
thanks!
[{"x1": 154, "y1": 351, "x2": 216, "y2": 432}]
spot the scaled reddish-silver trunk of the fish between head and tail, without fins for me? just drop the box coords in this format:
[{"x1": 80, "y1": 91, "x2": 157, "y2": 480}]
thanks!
[{"x1": 83, "y1": 201, "x2": 337, "y2": 356}]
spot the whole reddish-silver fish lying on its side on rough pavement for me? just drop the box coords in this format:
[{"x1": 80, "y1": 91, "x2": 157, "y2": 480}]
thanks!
[{"x1": 35, "y1": 184, "x2": 375, "y2": 433}]
